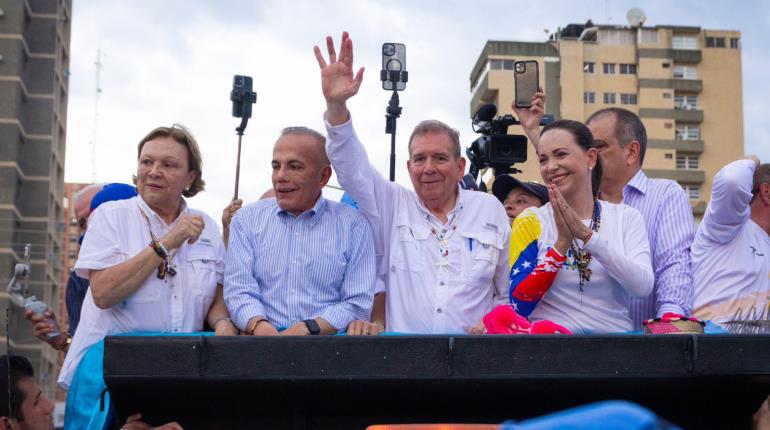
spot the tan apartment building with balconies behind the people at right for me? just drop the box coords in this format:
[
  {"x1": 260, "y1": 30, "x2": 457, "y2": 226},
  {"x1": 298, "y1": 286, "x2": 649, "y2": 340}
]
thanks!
[{"x1": 470, "y1": 21, "x2": 744, "y2": 221}]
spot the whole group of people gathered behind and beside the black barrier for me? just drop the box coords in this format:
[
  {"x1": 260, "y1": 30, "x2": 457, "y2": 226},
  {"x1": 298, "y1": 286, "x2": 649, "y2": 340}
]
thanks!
[{"x1": 6, "y1": 33, "x2": 770, "y2": 428}]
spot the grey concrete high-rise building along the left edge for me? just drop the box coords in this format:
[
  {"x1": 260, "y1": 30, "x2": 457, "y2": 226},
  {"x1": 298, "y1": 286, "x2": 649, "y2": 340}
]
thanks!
[{"x1": 0, "y1": 0, "x2": 72, "y2": 396}]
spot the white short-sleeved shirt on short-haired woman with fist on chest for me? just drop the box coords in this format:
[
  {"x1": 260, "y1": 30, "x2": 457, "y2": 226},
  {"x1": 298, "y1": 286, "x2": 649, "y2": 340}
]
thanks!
[{"x1": 58, "y1": 196, "x2": 225, "y2": 389}]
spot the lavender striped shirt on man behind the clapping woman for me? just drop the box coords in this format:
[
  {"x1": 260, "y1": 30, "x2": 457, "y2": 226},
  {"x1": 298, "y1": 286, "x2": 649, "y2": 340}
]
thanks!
[{"x1": 623, "y1": 170, "x2": 695, "y2": 330}]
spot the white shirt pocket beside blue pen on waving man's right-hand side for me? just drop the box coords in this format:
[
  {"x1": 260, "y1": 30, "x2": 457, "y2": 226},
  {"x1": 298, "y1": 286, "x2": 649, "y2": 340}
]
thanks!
[{"x1": 461, "y1": 231, "x2": 503, "y2": 288}]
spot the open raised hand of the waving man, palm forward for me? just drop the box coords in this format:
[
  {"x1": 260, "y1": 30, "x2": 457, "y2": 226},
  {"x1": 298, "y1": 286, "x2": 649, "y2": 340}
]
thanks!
[{"x1": 313, "y1": 31, "x2": 364, "y2": 125}]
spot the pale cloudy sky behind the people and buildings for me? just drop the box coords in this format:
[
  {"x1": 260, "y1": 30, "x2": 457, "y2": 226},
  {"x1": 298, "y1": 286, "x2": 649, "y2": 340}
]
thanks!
[{"x1": 65, "y1": 0, "x2": 770, "y2": 225}]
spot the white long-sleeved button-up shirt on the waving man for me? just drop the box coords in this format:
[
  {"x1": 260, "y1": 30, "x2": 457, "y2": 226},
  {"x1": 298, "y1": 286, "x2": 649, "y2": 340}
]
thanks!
[{"x1": 326, "y1": 116, "x2": 511, "y2": 334}]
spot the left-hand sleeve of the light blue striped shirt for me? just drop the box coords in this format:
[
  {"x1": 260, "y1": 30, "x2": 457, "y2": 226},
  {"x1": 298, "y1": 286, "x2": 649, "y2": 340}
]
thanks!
[{"x1": 224, "y1": 212, "x2": 265, "y2": 330}]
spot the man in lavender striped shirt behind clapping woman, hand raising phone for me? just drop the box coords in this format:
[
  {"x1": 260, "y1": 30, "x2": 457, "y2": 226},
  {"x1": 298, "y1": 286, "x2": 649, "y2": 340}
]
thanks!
[{"x1": 512, "y1": 101, "x2": 695, "y2": 330}]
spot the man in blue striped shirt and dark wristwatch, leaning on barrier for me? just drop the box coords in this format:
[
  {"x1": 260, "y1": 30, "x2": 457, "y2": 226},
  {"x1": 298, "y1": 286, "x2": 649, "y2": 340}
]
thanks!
[{"x1": 224, "y1": 127, "x2": 375, "y2": 336}]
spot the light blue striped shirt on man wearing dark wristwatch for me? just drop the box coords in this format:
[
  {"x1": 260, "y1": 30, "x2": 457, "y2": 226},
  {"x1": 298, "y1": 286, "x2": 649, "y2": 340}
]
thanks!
[{"x1": 224, "y1": 196, "x2": 376, "y2": 330}]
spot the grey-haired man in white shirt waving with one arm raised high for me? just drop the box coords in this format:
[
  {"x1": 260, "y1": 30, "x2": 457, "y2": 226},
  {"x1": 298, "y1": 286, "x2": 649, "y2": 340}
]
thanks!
[{"x1": 315, "y1": 33, "x2": 510, "y2": 334}]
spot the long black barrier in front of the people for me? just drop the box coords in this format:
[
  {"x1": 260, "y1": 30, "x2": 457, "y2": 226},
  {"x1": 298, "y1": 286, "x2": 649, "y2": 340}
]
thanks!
[{"x1": 104, "y1": 335, "x2": 770, "y2": 429}]
